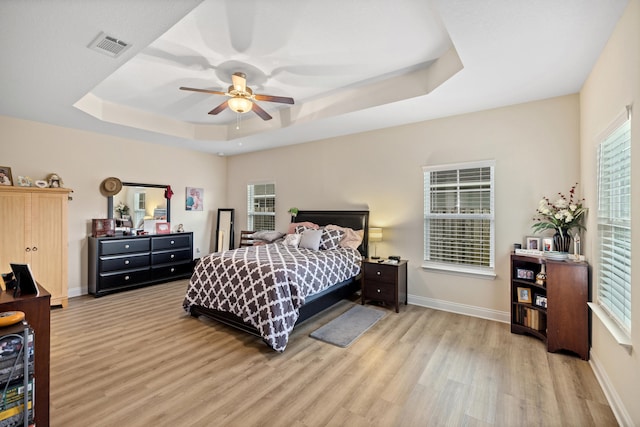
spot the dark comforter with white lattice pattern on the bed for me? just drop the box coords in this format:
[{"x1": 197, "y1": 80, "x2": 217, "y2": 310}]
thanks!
[{"x1": 183, "y1": 243, "x2": 362, "y2": 351}]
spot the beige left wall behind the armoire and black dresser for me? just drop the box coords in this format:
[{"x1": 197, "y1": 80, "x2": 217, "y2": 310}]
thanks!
[{"x1": 0, "y1": 116, "x2": 227, "y2": 296}]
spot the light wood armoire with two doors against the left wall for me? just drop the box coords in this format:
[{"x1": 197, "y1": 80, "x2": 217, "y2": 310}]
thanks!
[{"x1": 0, "y1": 185, "x2": 71, "y2": 307}]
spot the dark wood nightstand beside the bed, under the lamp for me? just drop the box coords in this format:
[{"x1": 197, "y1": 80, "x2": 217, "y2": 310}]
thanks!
[{"x1": 362, "y1": 259, "x2": 407, "y2": 313}]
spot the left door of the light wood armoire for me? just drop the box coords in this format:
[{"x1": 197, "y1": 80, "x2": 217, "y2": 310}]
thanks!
[{"x1": 0, "y1": 192, "x2": 31, "y2": 273}]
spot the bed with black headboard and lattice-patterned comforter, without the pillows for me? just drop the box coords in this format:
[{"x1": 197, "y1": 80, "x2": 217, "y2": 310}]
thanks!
[{"x1": 183, "y1": 211, "x2": 369, "y2": 352}]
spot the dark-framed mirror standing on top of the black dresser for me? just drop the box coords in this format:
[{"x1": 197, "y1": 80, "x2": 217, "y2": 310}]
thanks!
[{"x1": 107, "y1": 182, "x2": 171, "y2": 229}]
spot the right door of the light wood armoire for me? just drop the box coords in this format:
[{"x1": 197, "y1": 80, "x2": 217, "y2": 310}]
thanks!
[{"x1": 31, "y1": 194, "x2": 67, "y2": 305}]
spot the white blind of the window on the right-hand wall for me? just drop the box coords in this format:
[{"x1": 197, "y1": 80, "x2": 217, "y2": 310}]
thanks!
[{"x1": 597, "y1": 113, "x2": 631, "y2": 334}]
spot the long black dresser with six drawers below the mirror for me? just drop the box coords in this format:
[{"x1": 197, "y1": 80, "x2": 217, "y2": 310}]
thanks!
[{"x1": 89, "y1": 232, "x2": 193, "y2": 297}]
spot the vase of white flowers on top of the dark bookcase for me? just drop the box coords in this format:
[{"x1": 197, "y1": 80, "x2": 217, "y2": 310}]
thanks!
[{"x1": 531, "y1": 183, "x2": 587, "y2": 252}]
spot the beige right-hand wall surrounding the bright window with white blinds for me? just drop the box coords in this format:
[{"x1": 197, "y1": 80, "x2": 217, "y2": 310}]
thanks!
[{"x1": 580, "y1": 0, "x2": 640, "y2": 426}]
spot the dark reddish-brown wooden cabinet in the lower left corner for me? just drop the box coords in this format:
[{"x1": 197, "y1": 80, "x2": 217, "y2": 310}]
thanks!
[{"x1": 0, "y1": 285, "x2": 51, "y2": 427}]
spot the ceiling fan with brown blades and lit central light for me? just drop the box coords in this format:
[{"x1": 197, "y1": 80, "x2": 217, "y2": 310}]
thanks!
[{"x1": 180, "y1": 72, "x2": 293, "y2": 120}]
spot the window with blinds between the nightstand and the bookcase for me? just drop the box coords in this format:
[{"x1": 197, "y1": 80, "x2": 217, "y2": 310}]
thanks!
[{"x1": 423, "y1": 161, "x2": 495, "y2": 276}]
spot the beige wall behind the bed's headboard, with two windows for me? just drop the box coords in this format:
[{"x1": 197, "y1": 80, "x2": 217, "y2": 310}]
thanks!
[{"x1": 228, "y1": 95, "x2": 579, "y2": 321}]
